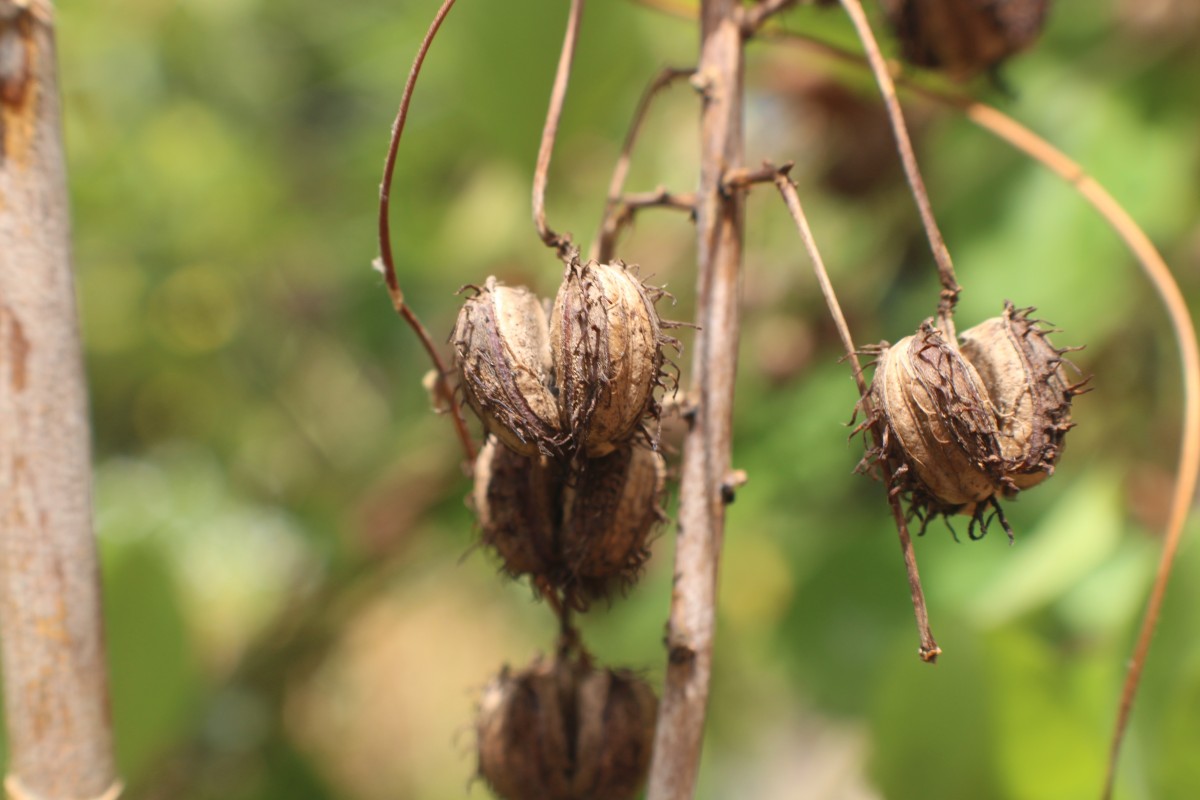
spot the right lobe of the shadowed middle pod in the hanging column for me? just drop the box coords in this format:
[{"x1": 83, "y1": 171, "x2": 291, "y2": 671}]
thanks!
[{"x1": 562, "y1": 445, "x2": 666, "y2": 595}]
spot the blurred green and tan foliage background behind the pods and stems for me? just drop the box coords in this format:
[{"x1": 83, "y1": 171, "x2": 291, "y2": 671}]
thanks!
[{"x1": 4, "y1": 0, "x2": 1200, "y2": 800}]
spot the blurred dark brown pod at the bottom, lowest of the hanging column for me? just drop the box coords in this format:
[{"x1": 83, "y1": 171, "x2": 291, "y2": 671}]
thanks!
[{"x1": 475, "y1": 656, "x2": 658, "y2": 800}]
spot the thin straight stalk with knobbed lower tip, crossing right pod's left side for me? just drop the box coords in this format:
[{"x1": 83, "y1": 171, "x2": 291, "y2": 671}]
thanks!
[{"x1": 775, "y1": 164, "x2": 942, "y2": 663}]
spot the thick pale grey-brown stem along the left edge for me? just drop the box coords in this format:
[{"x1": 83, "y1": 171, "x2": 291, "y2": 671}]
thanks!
[{"x1": 0, "y1": 0, "x2": 120, "y2": 800}]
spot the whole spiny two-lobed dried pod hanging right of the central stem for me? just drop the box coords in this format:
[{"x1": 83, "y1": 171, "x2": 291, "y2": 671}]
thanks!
[{"x1": 860, "y1": 303, "x2": 1086, "y2": 539}]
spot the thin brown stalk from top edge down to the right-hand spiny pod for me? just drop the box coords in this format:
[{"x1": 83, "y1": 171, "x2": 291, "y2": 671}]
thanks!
[{"x1": 840, "y1": 0, "x2": 961, "y2": 342}]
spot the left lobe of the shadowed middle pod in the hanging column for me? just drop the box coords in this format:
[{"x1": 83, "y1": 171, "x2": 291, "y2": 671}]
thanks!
[{"x1": 472, "y1": 437, "x2": 563, "y2": 577}]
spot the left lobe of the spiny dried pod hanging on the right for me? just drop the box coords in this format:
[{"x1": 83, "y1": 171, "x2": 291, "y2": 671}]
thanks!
[{"x1": 870, "y1": 320, "x2": 1007, "y2": 513}]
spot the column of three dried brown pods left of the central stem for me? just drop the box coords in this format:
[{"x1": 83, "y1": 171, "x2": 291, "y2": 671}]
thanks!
[{"x1": 451, "y1": 259, "x2": 676, "y2": 800}]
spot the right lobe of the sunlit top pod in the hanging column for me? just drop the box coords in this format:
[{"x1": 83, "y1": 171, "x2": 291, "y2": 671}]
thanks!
[{"x1": 550, "y1": 263, "x2": 668, "y2": 457}]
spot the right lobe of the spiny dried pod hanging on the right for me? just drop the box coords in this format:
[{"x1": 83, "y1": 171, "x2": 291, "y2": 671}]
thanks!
[{"x1": 960, "y1": 302, "x2": 1079, "y2": 489}]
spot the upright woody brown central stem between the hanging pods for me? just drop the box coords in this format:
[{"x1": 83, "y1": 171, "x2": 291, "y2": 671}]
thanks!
[{"x1": 647, "y1": 0, "x2": 744, "y2": 800}]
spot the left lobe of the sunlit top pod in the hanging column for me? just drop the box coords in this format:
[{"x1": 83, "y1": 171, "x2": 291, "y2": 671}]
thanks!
[{"x1": 450, "y1": 277, "x2": 562, "y2": 456}]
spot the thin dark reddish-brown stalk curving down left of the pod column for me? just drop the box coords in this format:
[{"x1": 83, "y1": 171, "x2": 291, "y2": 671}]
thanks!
[{"x1": 376, "y1": 0, "x2": 475, "y2": 462}]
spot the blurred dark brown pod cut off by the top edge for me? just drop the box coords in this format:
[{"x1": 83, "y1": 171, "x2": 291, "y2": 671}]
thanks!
[{"x1": 881, "y1": 0, "x2": 1050, "y2": 80}]
